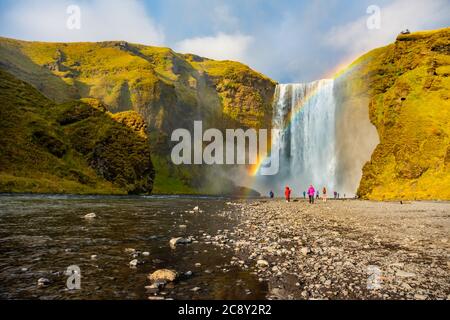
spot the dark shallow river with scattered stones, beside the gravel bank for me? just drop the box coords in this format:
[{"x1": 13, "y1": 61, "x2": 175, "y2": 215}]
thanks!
[{"x1": 0, "y1": 195, "x2": 267, "y2": 300}]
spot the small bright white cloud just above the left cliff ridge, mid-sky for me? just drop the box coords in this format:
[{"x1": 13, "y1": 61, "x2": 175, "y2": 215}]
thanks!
[{"x1": 175, "y1": 32, "x2": 253, "y2": 62}]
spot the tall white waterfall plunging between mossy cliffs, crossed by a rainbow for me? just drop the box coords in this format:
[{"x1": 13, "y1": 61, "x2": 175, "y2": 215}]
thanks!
[{"x1": 271, "y1": 80, "x2": 338, "y2": 195}]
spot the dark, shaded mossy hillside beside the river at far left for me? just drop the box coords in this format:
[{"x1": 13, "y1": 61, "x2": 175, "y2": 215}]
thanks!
[{"x1": 0, "y1": 69, "x2": 154, "y2": 194}]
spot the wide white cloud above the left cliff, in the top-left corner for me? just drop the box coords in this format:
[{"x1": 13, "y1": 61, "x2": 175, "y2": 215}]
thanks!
[{"x1": 3, "y1": 0, "x2": 164, "y2": 45}]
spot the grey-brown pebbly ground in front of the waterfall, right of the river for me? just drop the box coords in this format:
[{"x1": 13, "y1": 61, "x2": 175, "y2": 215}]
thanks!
[{"x1": 208, "y1": 200, "x2": 450, "y2": 299}]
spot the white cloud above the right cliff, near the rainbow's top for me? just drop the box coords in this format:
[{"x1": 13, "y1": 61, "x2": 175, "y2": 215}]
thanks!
[{"x1": 324, "y1": 0, "x2": 450, "y2": 56}]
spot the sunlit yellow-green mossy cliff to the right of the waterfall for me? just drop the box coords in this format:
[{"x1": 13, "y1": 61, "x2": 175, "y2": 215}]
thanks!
[{"x1": 343, "y1": 28, "x2": 450, "y2": 200}]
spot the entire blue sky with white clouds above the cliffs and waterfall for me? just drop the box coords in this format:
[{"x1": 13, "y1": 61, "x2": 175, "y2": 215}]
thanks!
[{"x1": 0, "y1": 0, "x2": 450, "y2": 83}]
